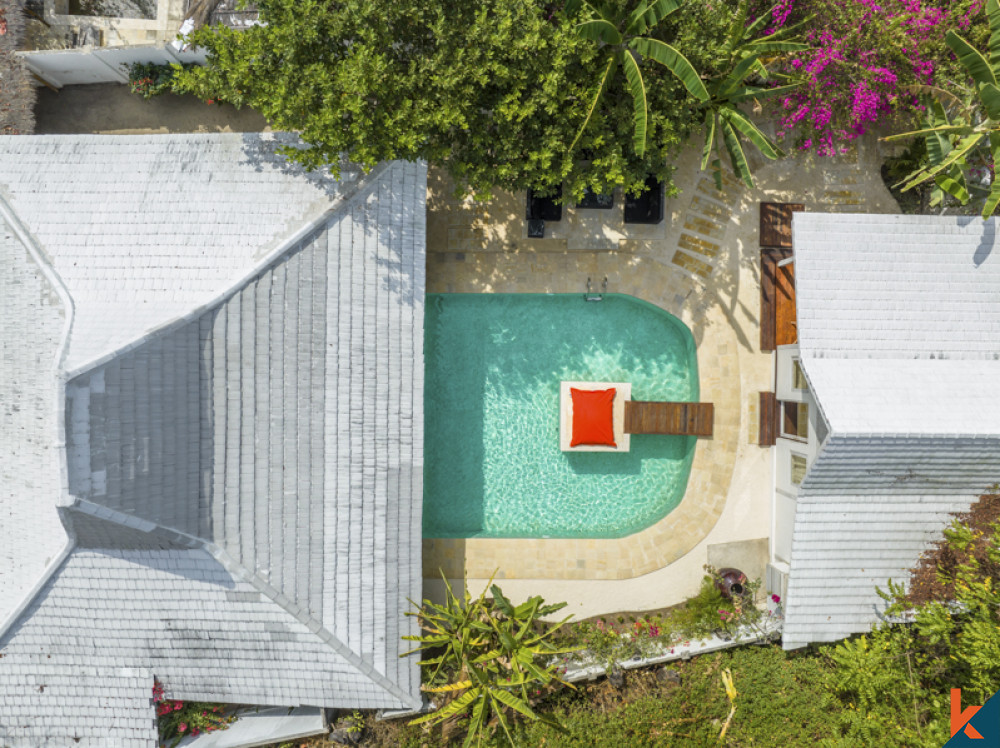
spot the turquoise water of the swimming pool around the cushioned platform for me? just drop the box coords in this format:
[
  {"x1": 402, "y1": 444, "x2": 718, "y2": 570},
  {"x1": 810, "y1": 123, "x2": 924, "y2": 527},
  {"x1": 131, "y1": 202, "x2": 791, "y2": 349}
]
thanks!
[{"x1": 423, "y1": 294, "x2": 698, "y2": 538}]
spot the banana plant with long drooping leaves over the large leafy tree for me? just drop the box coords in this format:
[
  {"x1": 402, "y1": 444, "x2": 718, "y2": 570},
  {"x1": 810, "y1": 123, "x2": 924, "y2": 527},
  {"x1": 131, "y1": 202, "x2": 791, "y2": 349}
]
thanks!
[{"x1": 565, "y1": 0, "x2": 709, "y2": 158}]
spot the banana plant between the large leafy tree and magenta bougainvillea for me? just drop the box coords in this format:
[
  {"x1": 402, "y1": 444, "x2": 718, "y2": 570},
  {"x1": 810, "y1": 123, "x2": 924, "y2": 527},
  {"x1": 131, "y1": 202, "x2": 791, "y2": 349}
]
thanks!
[{"x1": 701, "y1": 0, "x2": 808, "y2": 190}]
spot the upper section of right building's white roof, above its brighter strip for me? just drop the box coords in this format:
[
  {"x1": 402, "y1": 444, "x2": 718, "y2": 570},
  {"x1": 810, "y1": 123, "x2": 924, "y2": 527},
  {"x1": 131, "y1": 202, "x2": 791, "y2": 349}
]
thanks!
[{"x1": 792, "y1": 213, "x2": 1000, "y2": 360}]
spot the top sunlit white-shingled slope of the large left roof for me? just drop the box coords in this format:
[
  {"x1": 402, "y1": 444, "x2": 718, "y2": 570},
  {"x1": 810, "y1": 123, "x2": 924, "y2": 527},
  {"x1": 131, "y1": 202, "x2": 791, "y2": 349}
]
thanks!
[{"x1": 0, "y1": 133, "x2": 359, "y2": 371}]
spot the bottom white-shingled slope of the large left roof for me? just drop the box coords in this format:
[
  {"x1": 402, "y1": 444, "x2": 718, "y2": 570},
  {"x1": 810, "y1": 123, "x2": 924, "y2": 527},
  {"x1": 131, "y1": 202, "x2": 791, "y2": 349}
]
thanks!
[{"x1": 0, "y1": 549, "x2": 403, "y2": 748}]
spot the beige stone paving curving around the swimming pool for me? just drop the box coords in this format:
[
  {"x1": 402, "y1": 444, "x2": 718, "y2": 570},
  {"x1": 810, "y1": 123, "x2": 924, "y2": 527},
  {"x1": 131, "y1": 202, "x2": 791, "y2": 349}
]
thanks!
[{"x1": 424, "y1": 134, "x2": 898, "y2": 616}]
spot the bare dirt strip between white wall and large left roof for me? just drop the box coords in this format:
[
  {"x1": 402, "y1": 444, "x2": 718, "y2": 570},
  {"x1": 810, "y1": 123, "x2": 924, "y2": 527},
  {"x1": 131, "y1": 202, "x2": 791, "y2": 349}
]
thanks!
[{"x1": 35, "y1": 83, "x2": 270, "y2": 135}]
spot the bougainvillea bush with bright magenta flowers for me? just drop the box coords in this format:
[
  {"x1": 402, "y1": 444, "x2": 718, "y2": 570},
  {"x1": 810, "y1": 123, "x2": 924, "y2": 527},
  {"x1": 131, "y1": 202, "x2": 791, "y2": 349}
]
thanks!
[{"x1": 760, "y1": 0, "x2": 983, "y2": 155}]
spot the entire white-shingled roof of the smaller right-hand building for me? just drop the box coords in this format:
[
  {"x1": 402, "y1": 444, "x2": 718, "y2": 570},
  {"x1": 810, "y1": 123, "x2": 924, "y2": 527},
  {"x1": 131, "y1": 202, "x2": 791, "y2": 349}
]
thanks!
[{"x1": 783, "y1": 213, "x2": 1000, "y2": 648}]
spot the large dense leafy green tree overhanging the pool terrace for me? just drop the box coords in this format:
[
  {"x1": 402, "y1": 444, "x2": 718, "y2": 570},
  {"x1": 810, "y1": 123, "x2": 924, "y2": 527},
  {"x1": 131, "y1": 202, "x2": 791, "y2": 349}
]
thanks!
[{"x1": 176, "y1": 0, "x2": 752, "y2": 196}]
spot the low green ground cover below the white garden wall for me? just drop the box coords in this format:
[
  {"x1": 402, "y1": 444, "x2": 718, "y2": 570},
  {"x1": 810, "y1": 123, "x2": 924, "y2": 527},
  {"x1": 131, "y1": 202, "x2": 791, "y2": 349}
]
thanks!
[{"x1": 392, "y1": 645, "x2": 857, "y2": 748}]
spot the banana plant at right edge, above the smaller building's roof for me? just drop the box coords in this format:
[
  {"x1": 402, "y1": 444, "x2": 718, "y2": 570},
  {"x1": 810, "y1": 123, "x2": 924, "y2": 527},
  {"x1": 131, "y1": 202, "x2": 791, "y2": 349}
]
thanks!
[{"x1": 885, "y1": 0, "x2": 1000, "y2": 219}]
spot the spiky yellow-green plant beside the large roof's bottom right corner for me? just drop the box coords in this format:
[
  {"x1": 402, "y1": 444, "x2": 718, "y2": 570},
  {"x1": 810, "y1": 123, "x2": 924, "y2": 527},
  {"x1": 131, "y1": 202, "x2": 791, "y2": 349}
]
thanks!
[{"x1": 403, "y1": 579, "x2": 574, "y2": 746}]
